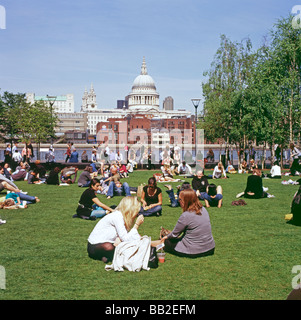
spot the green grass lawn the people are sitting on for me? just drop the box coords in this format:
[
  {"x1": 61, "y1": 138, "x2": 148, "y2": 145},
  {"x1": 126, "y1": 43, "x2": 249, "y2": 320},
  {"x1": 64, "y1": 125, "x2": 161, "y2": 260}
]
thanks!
[{"x1": 0, "y1": 171, "x2": 301, "y2": 300}]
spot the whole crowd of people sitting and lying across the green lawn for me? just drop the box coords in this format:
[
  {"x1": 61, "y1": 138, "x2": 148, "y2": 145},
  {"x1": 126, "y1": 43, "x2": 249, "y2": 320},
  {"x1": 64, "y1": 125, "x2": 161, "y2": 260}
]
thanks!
[{"x1": 0, "y1": 144, "x2": 301, "y2": 270}]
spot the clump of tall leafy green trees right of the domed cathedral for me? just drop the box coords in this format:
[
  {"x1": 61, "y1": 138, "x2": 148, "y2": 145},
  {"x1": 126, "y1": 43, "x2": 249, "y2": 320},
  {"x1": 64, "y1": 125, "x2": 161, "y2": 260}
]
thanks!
[{"x1": 202, "y1": 16, "x2": 301, "y2": 168}]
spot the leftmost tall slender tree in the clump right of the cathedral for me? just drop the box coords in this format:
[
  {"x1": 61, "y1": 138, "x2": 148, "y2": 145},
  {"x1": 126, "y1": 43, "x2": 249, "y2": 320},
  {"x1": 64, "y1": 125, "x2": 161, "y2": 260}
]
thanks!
[{"x1": 203, "y1": 35, "x2": 254, "y2": 164}]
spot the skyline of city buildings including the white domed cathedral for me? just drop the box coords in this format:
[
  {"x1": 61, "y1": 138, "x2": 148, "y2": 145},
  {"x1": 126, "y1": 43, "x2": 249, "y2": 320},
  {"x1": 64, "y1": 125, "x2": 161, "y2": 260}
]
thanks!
[{"x1": 26, "y1": 57, "x2": 193, "y2": 141}]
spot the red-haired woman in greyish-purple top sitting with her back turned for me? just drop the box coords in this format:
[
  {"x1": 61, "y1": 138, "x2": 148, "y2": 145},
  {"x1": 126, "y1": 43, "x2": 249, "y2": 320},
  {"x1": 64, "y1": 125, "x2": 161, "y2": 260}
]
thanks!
[{"x1": 162, "y1": 189, "x2": 215, "y2": 258}]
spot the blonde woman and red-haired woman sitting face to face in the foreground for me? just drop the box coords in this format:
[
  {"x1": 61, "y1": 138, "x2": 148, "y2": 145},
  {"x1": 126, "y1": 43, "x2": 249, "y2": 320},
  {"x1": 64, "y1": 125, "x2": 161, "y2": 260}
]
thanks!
[{"x1": 87, "y1": 188, "x2": 215, "y2": 263}]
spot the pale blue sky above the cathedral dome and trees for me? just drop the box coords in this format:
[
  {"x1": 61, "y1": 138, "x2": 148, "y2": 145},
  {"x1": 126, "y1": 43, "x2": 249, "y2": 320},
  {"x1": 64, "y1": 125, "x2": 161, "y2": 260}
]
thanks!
[{"x1": 0, "y1": 0, "x2": 301, "y2": 112}]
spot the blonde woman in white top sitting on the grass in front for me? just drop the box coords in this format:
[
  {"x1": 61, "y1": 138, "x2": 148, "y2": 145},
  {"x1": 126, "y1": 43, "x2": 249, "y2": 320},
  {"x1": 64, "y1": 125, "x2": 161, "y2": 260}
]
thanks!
[{"x1": 88, "y1": 197, "x2": 144, "y2": 263}]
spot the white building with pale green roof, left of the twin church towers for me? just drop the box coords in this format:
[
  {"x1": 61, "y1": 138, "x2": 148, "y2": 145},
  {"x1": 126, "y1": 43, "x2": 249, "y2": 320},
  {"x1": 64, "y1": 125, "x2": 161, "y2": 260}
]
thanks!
[{"x1": 26, "y1": 93, "x2": 74, "y2": 113}]
